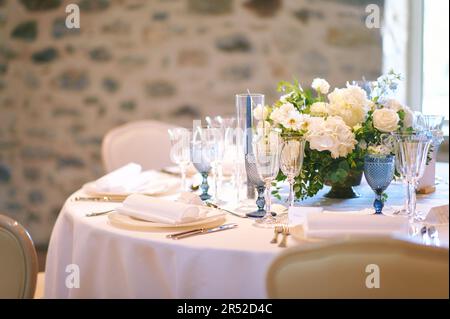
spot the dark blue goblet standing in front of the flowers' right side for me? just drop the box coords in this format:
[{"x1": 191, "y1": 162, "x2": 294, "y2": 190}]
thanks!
[{"x1": 364, "y1": 155, "x2": 395, "y2": 214}]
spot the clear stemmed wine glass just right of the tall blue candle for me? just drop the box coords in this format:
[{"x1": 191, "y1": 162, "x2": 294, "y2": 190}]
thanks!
[{"x1": 253, "y1": 130, "x2": 281, "y2": 227}]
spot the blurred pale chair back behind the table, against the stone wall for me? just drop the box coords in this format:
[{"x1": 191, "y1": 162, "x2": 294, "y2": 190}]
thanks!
[{"x1": 102, "y1": 121, "x2": 174, "y2": 172}]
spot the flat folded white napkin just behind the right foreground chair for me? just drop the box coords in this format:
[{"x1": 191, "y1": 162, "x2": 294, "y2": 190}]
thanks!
[{"x1": 303, "y1": 213, "x2": 409, "y2": 238}]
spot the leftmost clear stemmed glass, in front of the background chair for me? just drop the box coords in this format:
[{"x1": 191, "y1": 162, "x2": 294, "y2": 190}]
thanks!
[{"x1": 168, "y1": 127, "x2": 192, "y2": 191}]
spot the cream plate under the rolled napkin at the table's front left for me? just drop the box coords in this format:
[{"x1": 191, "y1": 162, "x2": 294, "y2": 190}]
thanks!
[{"x1": 108, "y1": 212, "x2": 226, "y2": 231}]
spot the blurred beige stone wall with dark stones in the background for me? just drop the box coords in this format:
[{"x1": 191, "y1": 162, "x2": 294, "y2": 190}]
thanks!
[{"x1": 0, "y1": 0, "x2": 383, "y2": 248}]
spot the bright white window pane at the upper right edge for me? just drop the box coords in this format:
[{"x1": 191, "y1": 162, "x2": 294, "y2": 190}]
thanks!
[{"x1": 422, "y1": 0, "x2": 449, "y2": 120}]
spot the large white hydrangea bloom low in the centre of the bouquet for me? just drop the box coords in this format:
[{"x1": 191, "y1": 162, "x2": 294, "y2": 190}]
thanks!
[{"x1": 306, "y1": 116, "x2": 357, "y2": 158}]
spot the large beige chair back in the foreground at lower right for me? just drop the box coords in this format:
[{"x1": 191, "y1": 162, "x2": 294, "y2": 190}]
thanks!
[{"x1": 267, "y1": 239, "x2": 449, "y2": 299}]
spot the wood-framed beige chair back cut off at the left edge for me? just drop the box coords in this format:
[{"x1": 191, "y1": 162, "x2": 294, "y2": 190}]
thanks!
[{"x1": 0, "y1": 215, "x2": 38, "y2": 299}]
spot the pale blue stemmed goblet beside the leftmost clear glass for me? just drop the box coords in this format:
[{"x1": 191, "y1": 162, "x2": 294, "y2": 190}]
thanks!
[{"x1": 191, "y1": 126, "x2": 217, "y2": 201}]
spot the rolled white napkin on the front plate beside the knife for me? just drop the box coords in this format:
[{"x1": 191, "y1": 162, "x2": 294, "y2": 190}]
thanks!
[{"x1": 116, "y1": 194, "x2": 210, "y2": 225}]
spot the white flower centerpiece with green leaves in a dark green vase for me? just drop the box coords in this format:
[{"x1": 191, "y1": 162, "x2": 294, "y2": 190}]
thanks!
[{"x1": 254, "y1": 72, "x2": 413, "y2": 199}]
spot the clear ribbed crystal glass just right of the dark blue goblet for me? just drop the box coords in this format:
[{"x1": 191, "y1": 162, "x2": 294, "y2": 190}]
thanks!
[{"x1": 393, "y1": 132, "x2": 433, "y2": 222}]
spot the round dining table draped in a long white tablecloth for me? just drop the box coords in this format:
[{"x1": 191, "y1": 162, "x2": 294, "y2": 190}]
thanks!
[{"x1": 45, "y1": 164, "x2": 449, "y2": 299}]
